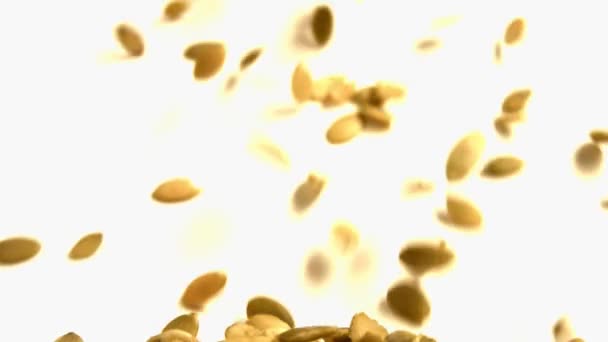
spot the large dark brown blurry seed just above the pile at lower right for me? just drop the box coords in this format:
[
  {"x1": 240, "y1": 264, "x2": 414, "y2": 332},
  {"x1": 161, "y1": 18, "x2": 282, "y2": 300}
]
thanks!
[{"x1": 386, "y1": 282, "x2": 431, "y2": 326}]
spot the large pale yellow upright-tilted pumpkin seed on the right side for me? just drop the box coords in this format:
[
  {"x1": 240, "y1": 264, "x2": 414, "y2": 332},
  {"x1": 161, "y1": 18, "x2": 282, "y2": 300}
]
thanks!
[{"x1": 445, "y1": 132, "x2": 486, "y2": 182}]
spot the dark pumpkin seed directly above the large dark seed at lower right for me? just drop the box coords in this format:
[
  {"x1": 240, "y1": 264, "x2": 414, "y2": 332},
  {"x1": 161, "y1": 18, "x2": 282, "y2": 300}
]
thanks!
[{"x1": 399, "y1": 240, "x2": 454, "y2": 275}]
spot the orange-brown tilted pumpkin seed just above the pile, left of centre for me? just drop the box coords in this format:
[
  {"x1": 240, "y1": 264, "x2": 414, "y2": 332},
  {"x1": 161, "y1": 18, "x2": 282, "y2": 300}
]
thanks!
[{"x1": 181, "y1": 271, "x2": 227, "y2": 311}]
